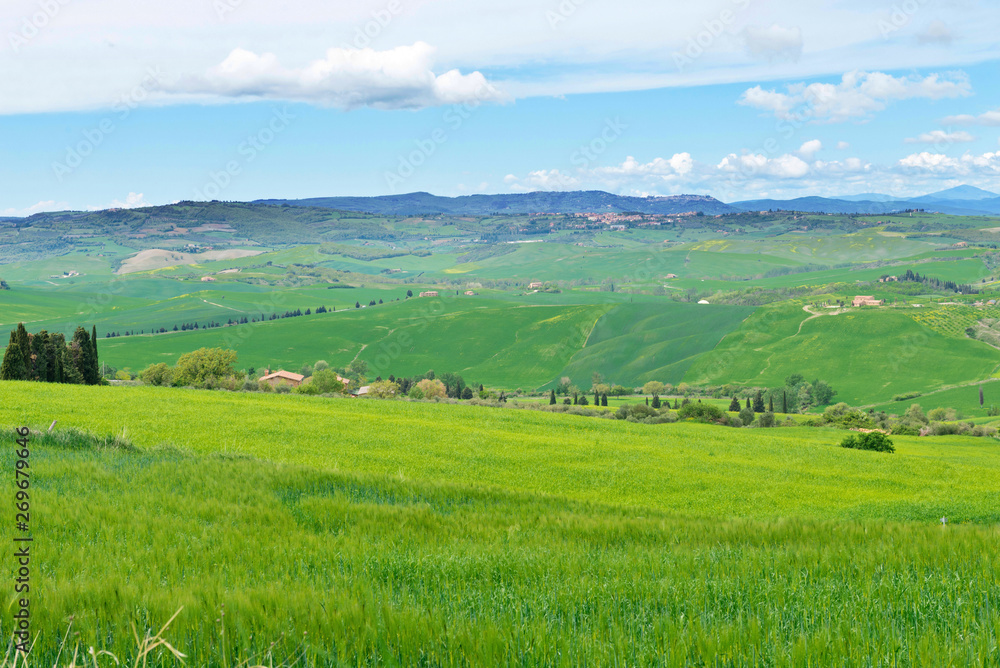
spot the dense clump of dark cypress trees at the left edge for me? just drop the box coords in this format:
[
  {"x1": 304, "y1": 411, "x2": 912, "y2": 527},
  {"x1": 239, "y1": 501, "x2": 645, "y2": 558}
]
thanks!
[{"x1": 0, "y1": 323, "x2": 102, "y2": 385}]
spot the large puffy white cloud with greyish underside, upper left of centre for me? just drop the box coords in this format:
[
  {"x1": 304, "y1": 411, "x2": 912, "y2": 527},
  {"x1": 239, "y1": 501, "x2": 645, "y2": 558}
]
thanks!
[{"x1": 168, "y1": 42, "x2": 505, "y2": 109}]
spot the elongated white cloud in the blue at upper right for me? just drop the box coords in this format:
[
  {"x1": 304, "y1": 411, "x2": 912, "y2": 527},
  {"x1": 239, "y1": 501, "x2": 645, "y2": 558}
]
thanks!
[{"x1": 739, "y1": 70, "x2": 972, "y2": 122}]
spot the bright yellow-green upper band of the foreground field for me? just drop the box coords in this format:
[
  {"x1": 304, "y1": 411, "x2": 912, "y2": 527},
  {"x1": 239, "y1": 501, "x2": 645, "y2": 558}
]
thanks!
[{"x1": 0, "y1": 382, "x2": 1000, "y2": 523}]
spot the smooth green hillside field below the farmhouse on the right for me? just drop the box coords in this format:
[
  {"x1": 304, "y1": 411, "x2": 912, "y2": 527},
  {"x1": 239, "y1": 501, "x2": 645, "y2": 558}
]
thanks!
[{"x1": 685, "y1": 303, "x2": 1000, "y2": 405}]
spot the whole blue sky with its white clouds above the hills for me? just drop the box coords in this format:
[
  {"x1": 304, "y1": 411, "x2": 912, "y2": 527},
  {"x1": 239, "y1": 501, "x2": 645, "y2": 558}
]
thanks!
[{"x1": 0, "y1": 0, "x2": 1000, "y2": 215}]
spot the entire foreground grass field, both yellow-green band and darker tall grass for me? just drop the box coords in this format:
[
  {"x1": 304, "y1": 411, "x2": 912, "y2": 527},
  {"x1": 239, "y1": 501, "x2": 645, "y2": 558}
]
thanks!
[{"x1": 0, "y1": 383, "x2": 1000, "y2": 666}]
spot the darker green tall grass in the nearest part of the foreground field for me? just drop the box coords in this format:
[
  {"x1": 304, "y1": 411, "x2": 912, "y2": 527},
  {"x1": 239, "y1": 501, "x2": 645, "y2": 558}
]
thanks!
[{"x1": 0, "y1": 433, "x2": 1000, "y2": 666}]
